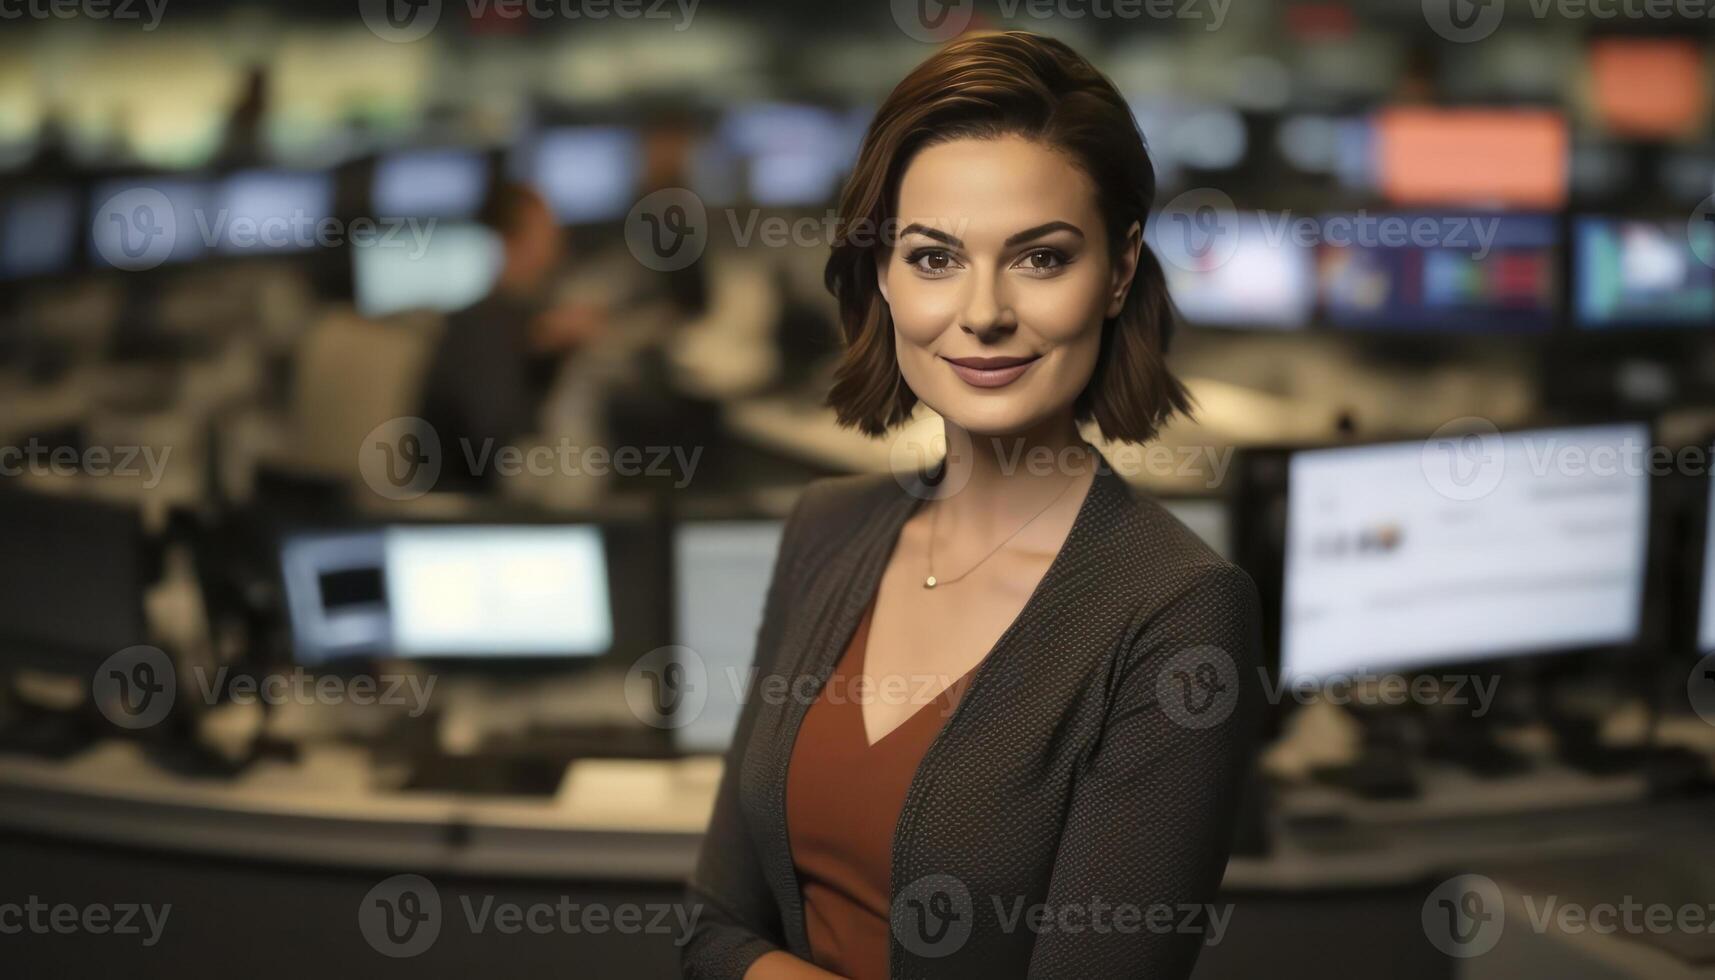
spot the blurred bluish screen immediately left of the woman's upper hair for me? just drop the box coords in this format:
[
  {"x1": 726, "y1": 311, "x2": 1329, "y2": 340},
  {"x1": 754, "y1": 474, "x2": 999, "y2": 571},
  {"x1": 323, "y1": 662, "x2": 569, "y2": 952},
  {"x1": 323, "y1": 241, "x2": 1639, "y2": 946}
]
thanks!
[{"x1": 720, "y1": 103, "x2": 866, "y2": 208}]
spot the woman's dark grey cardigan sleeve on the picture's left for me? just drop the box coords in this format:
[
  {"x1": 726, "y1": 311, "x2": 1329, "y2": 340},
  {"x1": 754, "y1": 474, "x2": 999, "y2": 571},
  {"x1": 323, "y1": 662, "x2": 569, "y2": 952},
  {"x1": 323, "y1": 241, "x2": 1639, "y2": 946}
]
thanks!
[{"x1": 679, "y1": 489, "x2": 811, "y2": 980}]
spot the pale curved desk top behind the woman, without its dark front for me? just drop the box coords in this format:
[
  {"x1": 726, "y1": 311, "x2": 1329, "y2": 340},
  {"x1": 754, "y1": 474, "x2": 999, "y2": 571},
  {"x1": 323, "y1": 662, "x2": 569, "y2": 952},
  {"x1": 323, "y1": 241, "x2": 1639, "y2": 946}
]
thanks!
[{"x1": 0, "y1": 743, "x2": 1715, "y2": 891}]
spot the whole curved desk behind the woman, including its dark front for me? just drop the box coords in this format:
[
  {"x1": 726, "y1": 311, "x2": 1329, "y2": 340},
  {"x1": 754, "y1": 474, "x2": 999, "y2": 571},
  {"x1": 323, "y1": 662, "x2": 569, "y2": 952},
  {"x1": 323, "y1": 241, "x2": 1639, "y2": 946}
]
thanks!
[{"x1": 0, "y1": 743, "x2": 1715, "y2": 980}]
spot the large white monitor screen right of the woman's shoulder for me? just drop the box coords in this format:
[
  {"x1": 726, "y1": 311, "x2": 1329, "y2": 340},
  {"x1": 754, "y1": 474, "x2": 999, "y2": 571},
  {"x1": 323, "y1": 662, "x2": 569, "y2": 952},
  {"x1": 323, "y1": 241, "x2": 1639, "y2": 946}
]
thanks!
[{"x1": 1281, "y1": 424, "x2": 1650, "y2": 680}]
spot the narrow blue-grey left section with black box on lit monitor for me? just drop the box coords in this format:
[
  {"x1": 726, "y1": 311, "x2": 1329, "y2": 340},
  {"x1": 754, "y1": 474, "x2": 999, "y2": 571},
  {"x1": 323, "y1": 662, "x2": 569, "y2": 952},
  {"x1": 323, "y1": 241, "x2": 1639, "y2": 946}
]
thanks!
[{"x1": 280, "y1": 529, "x2": 393, "y2": 666}]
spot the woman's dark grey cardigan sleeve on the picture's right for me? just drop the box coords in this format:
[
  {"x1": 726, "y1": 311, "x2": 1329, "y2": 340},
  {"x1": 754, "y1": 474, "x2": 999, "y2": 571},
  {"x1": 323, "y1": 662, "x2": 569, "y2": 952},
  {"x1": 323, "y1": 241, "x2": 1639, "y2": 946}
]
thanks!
[{"x1": 1029, "y1": 565, "x2": 1262, "y2": 980}]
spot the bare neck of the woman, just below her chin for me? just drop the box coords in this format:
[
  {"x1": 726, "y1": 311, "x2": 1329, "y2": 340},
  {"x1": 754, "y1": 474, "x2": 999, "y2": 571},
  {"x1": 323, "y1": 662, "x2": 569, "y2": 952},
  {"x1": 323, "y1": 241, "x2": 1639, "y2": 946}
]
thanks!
[{"x1": 938, "y1": 414, "x2": 1096, "y2": 525}]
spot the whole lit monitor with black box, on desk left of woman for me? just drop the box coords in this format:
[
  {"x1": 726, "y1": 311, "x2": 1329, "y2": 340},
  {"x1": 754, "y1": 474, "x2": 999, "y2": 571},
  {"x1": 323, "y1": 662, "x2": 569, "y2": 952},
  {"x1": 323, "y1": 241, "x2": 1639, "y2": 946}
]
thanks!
[{"x1": 280, "y1": 523, "x2": 614, "y2": 666}]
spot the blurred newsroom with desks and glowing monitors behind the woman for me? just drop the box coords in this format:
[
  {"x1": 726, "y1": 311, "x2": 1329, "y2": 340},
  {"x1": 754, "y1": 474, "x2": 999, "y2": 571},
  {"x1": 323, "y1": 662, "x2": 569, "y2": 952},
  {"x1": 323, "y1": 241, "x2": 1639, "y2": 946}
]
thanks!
[{"x1": 0, "y1": 0, "x2": 1715, "y2": 977}]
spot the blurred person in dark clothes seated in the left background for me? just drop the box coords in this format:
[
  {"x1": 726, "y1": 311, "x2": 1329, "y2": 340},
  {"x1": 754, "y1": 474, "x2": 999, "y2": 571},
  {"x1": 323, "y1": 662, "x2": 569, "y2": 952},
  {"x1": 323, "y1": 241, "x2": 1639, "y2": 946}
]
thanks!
[{"x1": 422, "y1": 182, "x2": 604, "y2": 493}]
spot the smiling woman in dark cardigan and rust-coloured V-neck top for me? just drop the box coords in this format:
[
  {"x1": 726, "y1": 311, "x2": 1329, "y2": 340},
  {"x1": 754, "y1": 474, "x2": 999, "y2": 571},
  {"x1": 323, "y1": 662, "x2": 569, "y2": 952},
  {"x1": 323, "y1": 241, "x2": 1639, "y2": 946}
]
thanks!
[{"x1": 684, "y1": 33, "x2": 1261, "y2": 980}]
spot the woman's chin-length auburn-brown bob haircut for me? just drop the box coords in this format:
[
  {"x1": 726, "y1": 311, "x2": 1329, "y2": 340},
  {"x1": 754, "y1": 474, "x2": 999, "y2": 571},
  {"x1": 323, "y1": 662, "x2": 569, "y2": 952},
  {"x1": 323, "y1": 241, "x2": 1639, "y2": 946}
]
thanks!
[{"x1": 823, "y1": 31, "x2": 1190, "y2": 443}]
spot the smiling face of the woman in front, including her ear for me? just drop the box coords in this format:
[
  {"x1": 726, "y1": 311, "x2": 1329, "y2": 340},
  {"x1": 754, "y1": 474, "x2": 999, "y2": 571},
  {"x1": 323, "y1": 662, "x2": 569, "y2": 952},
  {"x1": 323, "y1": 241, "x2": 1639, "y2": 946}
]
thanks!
[{"x1": 878, "y1": 136, "x2": 1140, "y2": 436}]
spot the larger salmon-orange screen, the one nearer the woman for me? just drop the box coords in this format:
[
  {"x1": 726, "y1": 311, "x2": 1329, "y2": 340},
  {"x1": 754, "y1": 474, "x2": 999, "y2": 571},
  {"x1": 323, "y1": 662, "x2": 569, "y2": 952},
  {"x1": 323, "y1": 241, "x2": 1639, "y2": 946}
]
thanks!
[{"x1": 1375, "y1": 106, "x2": 1571, "y2": 211}]
